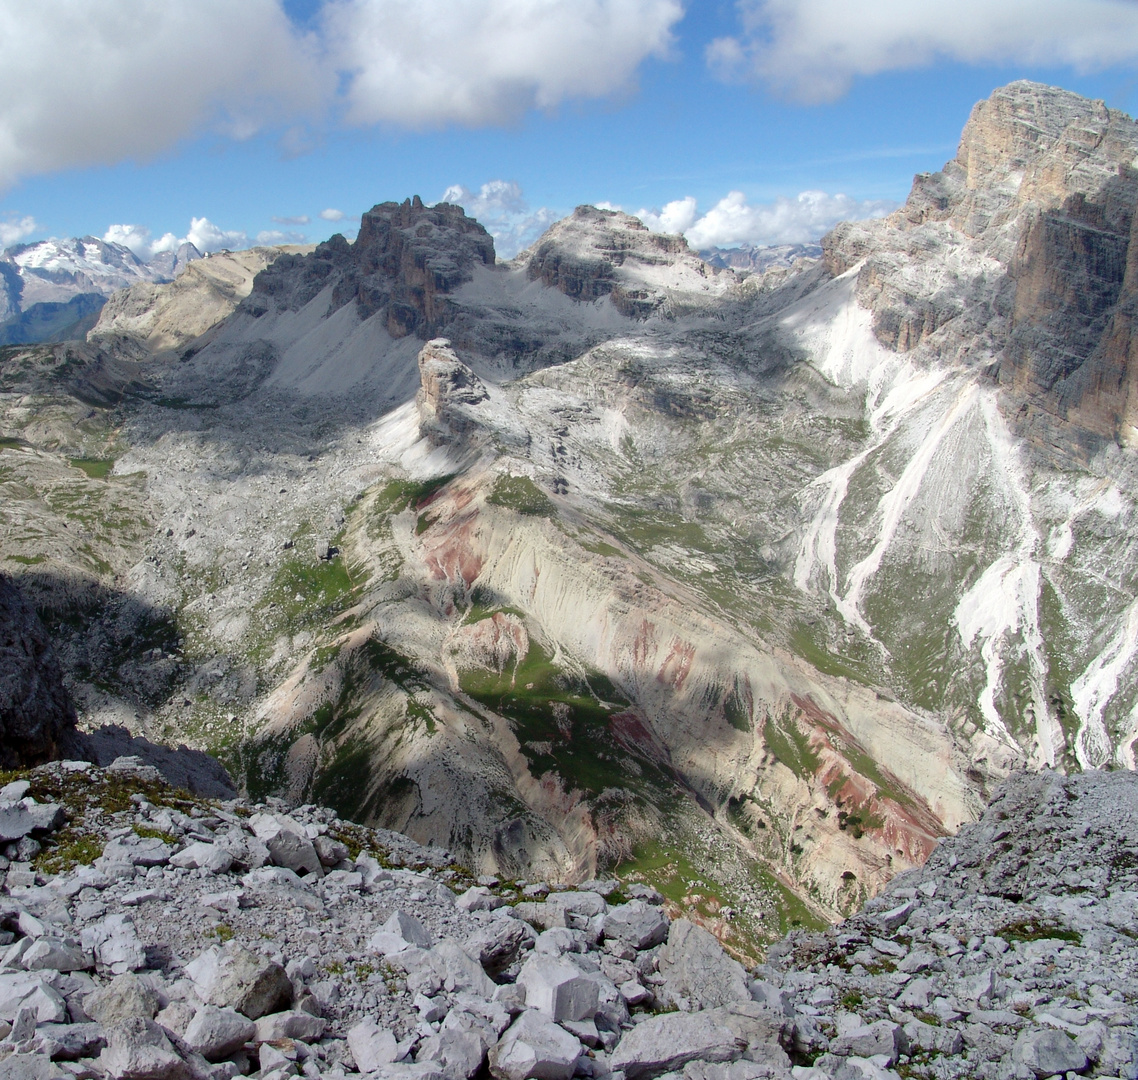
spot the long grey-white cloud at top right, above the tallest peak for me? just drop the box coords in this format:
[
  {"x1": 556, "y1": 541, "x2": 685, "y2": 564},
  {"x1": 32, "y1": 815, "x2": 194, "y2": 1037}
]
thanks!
[{"x1": 707, "y1": 0, "x2": 1138, "y2": 101}]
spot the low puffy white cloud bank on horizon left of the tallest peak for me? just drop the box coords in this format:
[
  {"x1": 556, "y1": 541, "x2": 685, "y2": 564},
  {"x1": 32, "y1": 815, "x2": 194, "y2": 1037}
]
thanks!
[{"x1": 636, "y1": 191, "x2": 897, "y2": 250}]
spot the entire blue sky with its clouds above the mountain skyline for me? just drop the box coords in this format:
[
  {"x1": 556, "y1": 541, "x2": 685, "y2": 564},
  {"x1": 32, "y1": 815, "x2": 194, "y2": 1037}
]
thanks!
[{"x1": 0, "y1": 0, "x2": 1138, "y2": 255}]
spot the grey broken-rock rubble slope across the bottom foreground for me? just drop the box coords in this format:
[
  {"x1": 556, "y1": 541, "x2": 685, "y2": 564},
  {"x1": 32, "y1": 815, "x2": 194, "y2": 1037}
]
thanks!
[{"x1": 0, "y1": 758, "x2": 1138, "y2": 1080}]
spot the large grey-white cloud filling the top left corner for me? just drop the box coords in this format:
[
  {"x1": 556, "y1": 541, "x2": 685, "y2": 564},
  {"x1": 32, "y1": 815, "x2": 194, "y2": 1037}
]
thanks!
[{"x1": 0, "y1": 0, "x2": 332, "y2": 189}]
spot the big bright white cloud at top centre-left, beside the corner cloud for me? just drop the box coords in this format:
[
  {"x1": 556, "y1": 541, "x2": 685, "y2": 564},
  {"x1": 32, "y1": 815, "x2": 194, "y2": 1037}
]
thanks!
[{"x1": 323, "y1": 0, "x2": 684, "y2": 127}]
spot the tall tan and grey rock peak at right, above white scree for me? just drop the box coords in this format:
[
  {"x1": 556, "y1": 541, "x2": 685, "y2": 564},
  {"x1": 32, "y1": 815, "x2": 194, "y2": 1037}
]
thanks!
[{"x1": 824, "y1": 82, "x2": 1138, "y2": 451}]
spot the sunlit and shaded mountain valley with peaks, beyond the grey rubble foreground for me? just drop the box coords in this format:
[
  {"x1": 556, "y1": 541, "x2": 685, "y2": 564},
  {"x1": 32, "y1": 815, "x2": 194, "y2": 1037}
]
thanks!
[{"x1": 0, "y1": 82, "x2": 1138, "y2": 953}]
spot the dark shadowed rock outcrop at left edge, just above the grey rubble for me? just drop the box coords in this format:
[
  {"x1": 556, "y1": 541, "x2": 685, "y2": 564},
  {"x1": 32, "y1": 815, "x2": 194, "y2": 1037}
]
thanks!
[{"x1": 0, "y1": 576, "x2": 75, "y2": 768}]
